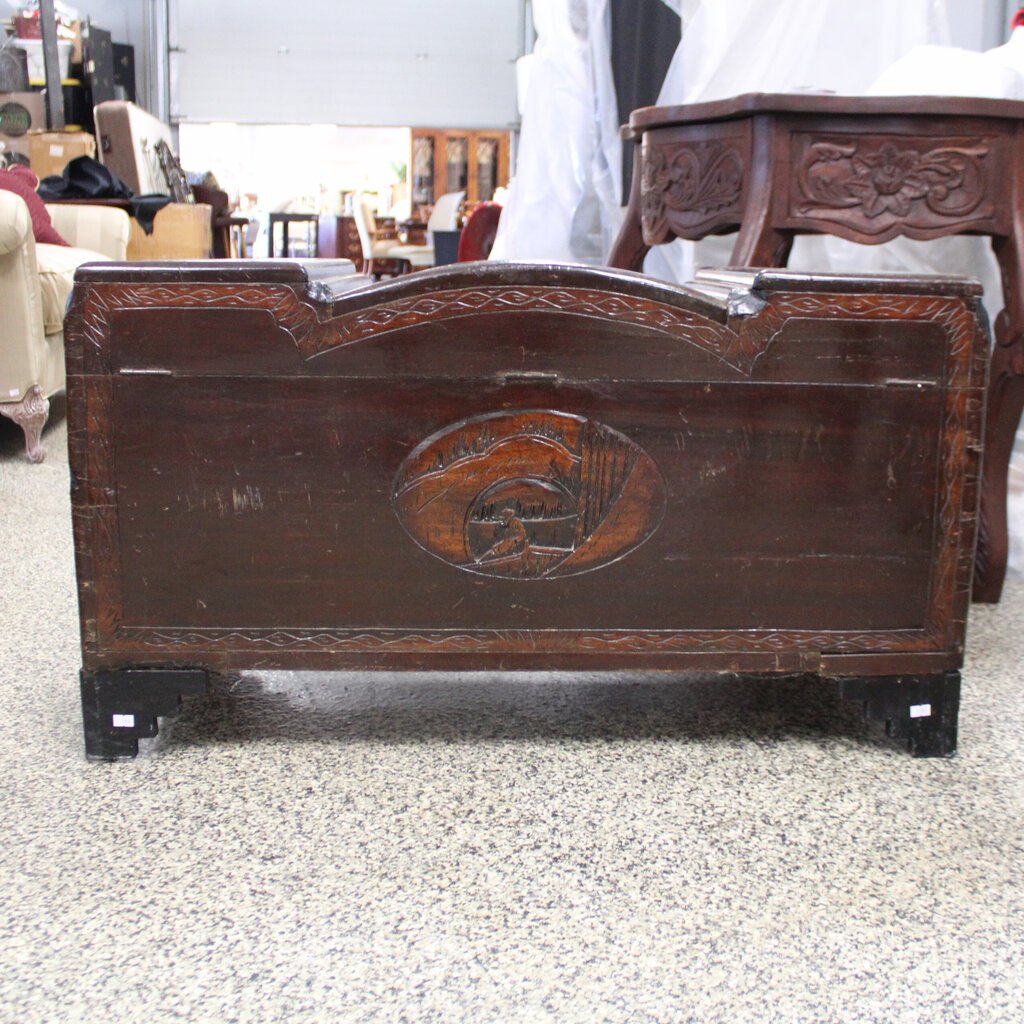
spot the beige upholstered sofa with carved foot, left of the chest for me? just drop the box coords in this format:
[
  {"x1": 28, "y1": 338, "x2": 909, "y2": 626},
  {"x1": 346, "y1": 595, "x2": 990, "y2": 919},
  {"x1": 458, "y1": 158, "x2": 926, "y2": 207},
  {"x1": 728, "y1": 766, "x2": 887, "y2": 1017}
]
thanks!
[{"x1": 0, "y1": 190, "x2": 129, "y2": 462}]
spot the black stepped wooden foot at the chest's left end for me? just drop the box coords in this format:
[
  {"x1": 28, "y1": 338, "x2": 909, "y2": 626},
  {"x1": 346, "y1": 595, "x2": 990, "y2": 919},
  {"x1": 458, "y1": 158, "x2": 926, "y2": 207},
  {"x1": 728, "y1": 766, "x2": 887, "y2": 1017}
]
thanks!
[{"x1": 81, "y1": 669, "x2": 209, "y2": 761}]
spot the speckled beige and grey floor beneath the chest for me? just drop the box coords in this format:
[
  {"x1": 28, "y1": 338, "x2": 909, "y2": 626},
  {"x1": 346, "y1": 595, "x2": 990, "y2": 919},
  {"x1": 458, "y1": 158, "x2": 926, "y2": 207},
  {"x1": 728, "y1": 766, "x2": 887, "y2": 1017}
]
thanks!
[{"x1": 0, "y1": 407, "x2": 1024, "y2": 1024}]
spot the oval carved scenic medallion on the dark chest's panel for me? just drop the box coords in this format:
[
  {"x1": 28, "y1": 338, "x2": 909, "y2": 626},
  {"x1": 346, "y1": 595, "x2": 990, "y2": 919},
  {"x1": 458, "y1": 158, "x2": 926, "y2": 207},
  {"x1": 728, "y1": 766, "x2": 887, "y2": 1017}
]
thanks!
[{"x1": 392, "y1": 411, "x2": 665, "y2": 580}]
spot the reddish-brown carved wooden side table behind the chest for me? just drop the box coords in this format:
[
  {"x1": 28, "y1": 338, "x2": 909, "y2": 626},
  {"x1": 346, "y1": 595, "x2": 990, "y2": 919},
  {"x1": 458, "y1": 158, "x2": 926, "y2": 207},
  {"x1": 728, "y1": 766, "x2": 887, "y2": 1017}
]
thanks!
[{"x1": 608, "y1": 94, "x2": 1024, "y2": 601}]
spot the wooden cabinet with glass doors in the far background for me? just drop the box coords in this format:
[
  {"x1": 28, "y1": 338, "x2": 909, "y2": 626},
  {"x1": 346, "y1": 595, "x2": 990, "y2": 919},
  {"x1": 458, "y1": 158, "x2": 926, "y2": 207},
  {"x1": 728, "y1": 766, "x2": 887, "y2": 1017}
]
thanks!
[{"x1": 409, "y1": 128, "x2": 509, "y2": 214}]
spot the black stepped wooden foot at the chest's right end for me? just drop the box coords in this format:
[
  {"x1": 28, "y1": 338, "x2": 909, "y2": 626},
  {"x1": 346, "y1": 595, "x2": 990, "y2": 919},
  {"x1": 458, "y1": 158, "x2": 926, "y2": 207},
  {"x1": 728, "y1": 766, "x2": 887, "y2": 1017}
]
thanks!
[{"x1": 839, "y1": 672, "x2": 959, "y2": 758}]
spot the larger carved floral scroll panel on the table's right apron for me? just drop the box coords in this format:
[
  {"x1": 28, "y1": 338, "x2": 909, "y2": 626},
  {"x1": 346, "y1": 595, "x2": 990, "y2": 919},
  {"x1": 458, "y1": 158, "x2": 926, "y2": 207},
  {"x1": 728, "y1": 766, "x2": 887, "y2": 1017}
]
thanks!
[{"x1": 795, "y1": 139, "x2": 990, "y2": 234}]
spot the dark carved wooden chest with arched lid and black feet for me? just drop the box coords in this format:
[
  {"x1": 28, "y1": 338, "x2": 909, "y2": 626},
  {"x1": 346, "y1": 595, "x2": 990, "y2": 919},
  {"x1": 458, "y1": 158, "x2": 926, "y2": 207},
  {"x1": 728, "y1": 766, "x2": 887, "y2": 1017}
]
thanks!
[{"x1": 67, "y1": 261, "x2": 987, "y2": 758}]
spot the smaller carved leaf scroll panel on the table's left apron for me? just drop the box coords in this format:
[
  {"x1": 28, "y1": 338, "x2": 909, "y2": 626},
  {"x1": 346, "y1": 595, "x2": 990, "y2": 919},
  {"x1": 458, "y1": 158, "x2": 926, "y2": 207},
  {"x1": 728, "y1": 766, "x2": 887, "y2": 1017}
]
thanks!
[{"x1": 640, "y1": 142, "x2": 743, "y2": 245}]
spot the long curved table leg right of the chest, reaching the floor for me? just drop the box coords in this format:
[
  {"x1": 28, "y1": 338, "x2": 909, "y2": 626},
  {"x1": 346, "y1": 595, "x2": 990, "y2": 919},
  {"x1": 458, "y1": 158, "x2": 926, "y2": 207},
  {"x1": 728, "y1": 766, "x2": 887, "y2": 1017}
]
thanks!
[{"x1": 974, "y1": 228, "x2": 1024, "y2": 602}]
